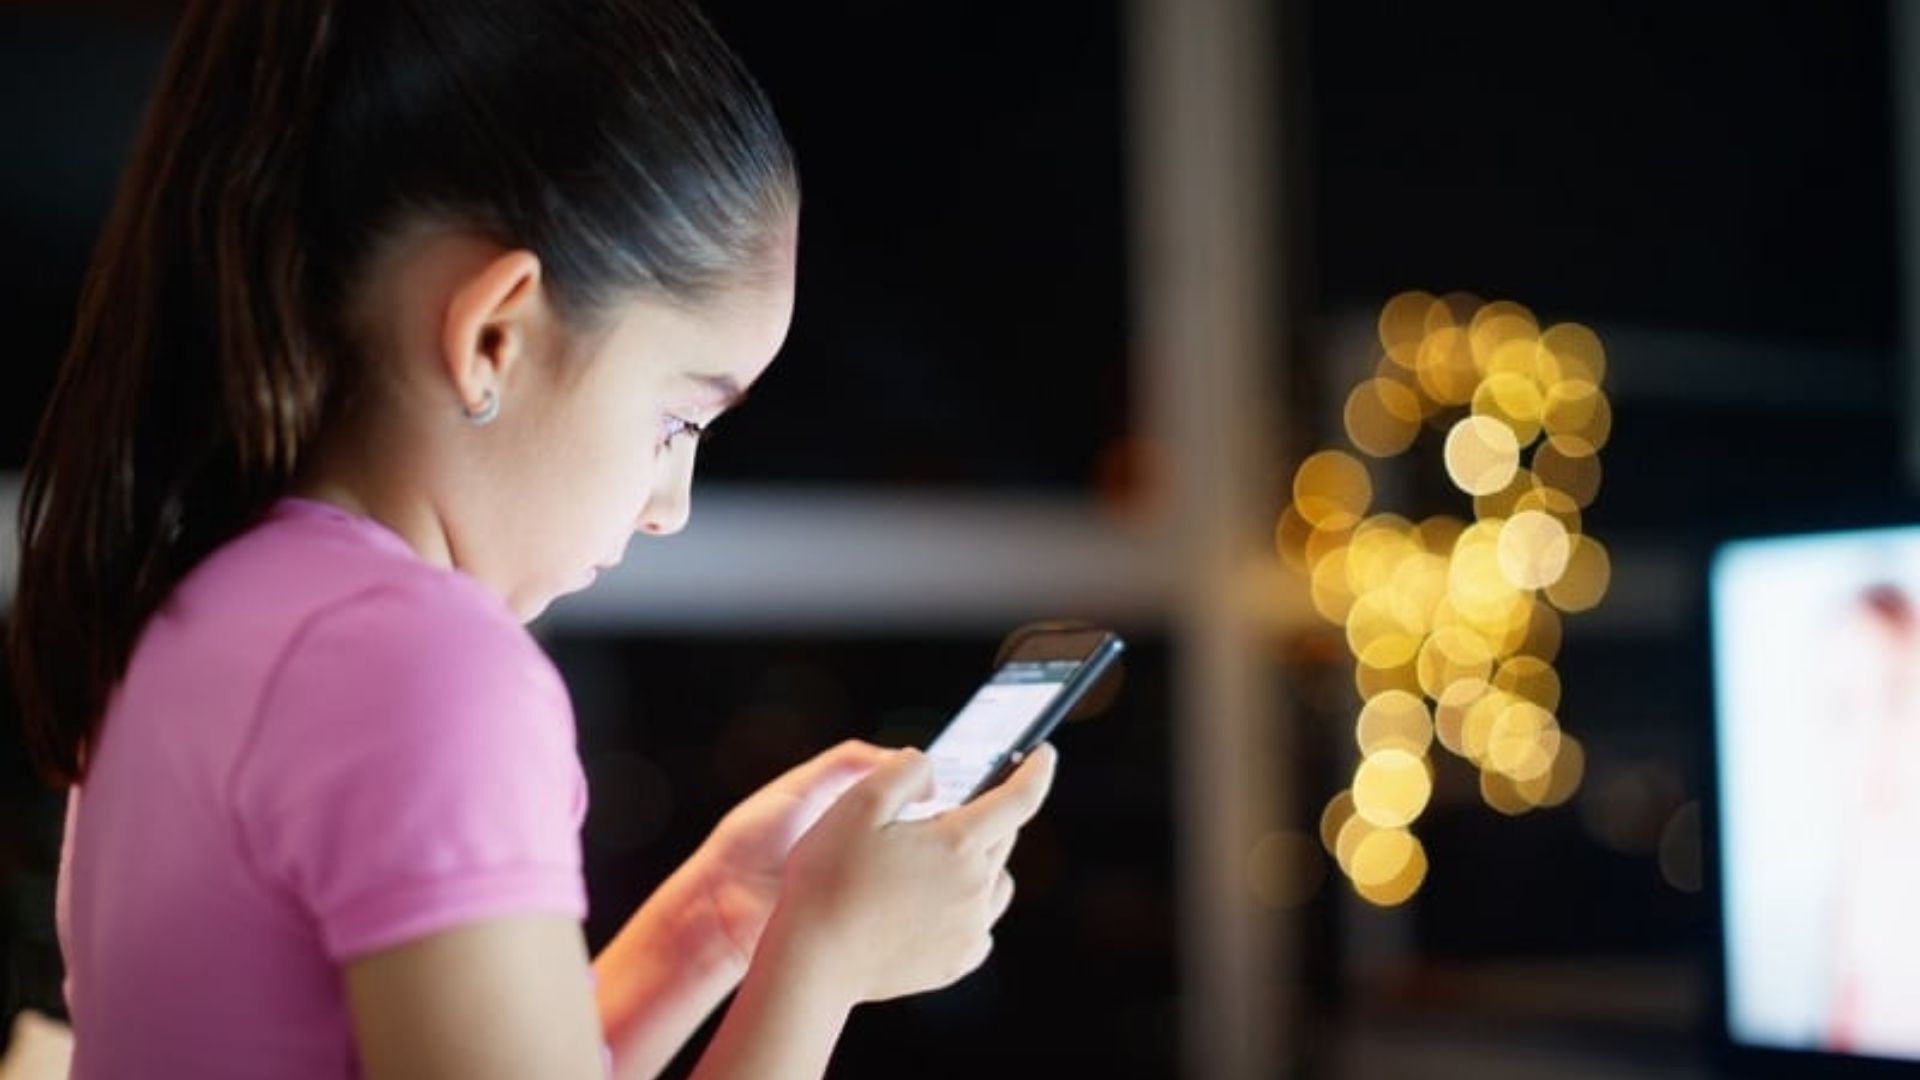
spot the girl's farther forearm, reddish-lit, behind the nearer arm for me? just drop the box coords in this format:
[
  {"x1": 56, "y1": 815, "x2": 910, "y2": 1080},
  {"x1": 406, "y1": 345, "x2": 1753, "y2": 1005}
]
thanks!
[{"x1": 593, "y1": 857, "x2": 745, "y2": 1080}]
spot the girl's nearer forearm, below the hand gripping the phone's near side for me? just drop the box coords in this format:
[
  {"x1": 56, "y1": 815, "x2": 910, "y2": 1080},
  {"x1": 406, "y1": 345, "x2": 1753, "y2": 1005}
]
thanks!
[{"x1": 691, "y1": 913, "x2": 854, "y2": 1080}]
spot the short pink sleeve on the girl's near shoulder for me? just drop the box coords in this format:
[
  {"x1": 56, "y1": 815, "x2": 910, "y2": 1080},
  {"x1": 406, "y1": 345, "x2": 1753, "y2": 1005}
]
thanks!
[{"x1": 228, "y1": 580, "x2": 586, "y2": 963}]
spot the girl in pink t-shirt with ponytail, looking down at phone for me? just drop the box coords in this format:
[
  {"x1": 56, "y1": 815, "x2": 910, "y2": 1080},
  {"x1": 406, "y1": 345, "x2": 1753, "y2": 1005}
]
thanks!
[{"x1": 10, "y1": 0, "x2": 1054, "y2": 1080}]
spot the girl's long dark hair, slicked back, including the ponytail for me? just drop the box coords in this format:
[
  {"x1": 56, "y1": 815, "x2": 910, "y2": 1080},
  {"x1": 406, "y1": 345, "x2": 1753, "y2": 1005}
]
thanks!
[{"x1": 8, "y1": 0, "x2": 799, "y2": 784}]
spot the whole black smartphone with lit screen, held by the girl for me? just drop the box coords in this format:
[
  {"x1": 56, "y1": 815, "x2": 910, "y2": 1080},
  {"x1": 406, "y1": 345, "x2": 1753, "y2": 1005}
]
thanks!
[{"x1": 895, "y1": 628, "x2": 1125, "y2": 821}]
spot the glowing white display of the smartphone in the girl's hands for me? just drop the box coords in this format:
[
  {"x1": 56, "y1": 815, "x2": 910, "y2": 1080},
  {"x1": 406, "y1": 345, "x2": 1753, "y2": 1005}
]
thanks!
[{"x1": 895, "y1": 659, "x2": 1081, "y2": 821}]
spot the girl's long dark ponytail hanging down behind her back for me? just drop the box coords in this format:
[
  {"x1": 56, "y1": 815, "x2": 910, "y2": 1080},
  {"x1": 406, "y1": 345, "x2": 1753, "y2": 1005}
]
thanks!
[{"x1": 8, "y1": 0, "x2": 334, "y2": 784}]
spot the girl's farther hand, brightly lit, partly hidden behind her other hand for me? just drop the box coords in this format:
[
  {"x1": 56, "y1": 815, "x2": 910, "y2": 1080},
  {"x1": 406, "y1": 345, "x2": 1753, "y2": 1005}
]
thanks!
[{"x1": 687, "y1": 738, "x2": 893, "y2": 970}]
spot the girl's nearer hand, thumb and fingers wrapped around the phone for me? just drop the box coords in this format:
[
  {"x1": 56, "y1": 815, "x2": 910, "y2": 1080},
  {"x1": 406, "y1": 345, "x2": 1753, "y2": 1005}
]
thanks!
[{"x1": 774, "y1": 744, "x2": 1058, "y2": 1001}]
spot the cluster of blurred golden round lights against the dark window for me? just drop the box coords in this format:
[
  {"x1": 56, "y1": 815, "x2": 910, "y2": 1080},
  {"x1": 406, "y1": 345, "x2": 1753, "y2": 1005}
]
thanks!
[{"x1": 1290, "y1": 290, "x2": 1605, "y2": 907}]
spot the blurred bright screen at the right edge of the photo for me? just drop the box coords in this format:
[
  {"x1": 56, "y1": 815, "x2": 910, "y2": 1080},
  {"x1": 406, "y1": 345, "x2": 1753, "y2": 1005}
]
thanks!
[{"x1": 1711, "y1": 528, "x2": 1920, "y2": 1061}]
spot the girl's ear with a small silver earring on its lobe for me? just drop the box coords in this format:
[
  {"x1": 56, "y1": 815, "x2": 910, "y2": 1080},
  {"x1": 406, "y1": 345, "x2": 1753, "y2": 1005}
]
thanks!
[{"x1": 440, "y1": 248, "x2": 545, "y2": 405}]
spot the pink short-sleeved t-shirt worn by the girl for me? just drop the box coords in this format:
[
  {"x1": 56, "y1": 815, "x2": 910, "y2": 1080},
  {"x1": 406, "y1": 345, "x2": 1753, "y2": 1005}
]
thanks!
[{"x1": 56, "y1": 498, "x2": 588, "y2": 1080}]
